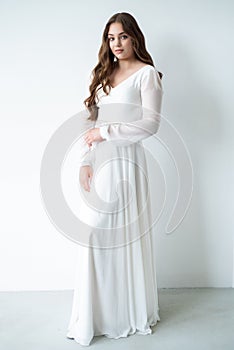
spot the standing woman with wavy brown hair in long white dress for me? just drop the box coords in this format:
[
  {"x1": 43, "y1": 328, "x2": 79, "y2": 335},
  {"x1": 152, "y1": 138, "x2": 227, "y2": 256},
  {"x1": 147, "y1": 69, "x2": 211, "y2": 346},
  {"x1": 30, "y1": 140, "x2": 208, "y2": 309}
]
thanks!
[{"x1": 67, "y1": 12, "x2": 163, "y2": 345}]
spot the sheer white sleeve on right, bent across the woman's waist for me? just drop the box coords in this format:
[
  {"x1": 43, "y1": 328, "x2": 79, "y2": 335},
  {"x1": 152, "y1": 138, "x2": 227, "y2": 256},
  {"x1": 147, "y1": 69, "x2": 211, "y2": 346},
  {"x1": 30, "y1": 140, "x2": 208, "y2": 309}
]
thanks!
[{"x1": 100, "y1": 69, "x2": 163, "y2": 145}]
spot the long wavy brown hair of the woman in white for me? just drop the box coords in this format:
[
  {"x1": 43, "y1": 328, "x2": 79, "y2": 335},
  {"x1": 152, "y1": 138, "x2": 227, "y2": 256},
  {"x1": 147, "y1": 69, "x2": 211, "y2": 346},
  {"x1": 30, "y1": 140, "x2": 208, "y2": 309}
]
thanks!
[{"x1": 84, "y1": 12, "x2": 163, "y2": 120}]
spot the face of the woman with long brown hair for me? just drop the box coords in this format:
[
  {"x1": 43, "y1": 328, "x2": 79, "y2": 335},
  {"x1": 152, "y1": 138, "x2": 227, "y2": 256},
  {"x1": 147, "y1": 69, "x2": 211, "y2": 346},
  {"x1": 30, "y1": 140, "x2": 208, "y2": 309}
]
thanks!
[{"x1": 108, "y1": 22, "x2": 135, "y2": 60}]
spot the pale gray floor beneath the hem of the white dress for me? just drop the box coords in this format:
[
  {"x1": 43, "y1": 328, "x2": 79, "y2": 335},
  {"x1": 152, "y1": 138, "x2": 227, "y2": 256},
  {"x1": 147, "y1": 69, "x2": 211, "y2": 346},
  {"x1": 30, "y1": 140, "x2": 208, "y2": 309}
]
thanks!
[{"x1": 0, "y1": 288, "x2": 234, "y2": 350}]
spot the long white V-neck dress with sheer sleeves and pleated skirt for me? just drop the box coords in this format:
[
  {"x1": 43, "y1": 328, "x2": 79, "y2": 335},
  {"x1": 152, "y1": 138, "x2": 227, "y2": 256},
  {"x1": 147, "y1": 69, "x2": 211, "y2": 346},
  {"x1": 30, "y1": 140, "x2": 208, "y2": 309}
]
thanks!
[{"x1": 67, "y1": 65, "x2": 163, "y2": 346}]
